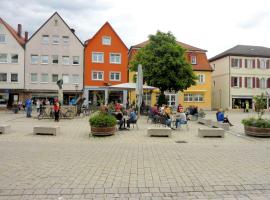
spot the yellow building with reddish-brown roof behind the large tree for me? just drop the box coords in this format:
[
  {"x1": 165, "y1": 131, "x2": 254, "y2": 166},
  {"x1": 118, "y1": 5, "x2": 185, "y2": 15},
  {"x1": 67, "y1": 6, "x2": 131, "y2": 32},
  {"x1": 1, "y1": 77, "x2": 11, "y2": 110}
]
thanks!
[{"x1": 129, "y1": 41, "x2": 213, "y2": 110}]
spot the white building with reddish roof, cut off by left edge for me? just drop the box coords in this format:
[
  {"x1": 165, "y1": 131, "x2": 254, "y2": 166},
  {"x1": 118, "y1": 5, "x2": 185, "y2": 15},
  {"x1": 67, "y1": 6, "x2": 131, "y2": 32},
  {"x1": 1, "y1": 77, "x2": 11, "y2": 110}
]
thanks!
[{"x1": 0, "y1": 18, "x2": 27, "y2": 107}]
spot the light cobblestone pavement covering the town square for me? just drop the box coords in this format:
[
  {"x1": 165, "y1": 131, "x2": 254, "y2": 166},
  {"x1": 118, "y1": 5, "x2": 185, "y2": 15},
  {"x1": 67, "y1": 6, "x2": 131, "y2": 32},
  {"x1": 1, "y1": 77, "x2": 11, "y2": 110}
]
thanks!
[{"x1": 0, "y1": 112, "x2": 270, "y2": 200}]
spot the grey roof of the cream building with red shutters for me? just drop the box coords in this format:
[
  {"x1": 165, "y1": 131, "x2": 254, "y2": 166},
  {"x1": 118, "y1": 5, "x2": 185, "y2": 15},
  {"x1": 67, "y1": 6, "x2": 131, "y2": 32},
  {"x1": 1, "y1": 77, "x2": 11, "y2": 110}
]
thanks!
[{"x1": 209, "y1": 45, "x2": 270, "y2": 62}]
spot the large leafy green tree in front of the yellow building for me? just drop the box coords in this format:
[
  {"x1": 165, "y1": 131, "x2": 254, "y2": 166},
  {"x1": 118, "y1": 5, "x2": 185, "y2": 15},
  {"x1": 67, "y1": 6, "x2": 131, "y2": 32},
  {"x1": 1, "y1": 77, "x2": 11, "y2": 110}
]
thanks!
[{"x1": 130, "y1": 31, "x2": 197, "y2": 103}]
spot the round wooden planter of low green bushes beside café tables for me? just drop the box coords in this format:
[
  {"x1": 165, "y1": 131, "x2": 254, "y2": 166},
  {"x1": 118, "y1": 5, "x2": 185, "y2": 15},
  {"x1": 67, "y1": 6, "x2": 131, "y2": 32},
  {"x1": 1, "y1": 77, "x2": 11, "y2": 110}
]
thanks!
[{"x1": 89, "y1": 111, "x2": 117, "y2": 136}]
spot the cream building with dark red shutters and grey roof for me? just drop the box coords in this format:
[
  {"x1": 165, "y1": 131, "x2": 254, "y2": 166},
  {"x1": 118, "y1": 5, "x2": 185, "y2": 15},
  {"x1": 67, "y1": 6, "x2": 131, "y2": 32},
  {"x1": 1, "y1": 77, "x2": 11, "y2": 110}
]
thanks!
[{"x1": 209, "y1": 45, "x2": 270, "y2": 109}]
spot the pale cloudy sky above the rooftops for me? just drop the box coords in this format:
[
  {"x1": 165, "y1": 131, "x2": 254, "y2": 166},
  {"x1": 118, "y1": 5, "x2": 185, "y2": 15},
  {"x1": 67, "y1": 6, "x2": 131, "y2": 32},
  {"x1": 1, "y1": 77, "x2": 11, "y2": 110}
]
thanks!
[{"x1": 0, "y1": 0, "x2": 270, "y2": 58}]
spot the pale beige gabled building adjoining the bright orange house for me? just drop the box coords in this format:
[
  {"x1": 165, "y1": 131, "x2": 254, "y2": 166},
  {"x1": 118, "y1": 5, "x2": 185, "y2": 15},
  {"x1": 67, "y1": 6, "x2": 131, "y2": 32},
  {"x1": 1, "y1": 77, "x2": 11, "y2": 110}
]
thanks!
[{"x1": 25, "y1": 12, "x2": 84, "y2": 104}]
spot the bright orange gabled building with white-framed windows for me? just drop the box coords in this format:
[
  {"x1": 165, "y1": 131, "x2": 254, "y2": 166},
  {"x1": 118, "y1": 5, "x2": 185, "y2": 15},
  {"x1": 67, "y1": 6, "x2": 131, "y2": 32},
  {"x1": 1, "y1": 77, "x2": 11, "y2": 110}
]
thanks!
[{"x1": 84, "y1": 22, "x2": 128, "y2": 105}]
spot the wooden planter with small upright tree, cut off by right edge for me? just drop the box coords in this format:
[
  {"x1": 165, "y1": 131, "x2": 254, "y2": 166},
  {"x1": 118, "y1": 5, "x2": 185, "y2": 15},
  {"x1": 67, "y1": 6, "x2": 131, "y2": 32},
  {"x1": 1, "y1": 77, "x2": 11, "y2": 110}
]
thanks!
[{"x1": 242, "y1": 94, "x2": 270, "y2": 137}]
